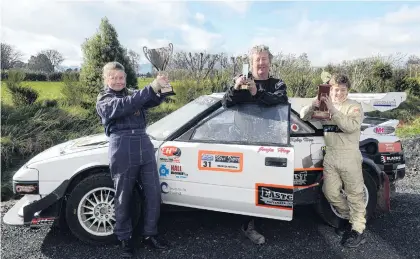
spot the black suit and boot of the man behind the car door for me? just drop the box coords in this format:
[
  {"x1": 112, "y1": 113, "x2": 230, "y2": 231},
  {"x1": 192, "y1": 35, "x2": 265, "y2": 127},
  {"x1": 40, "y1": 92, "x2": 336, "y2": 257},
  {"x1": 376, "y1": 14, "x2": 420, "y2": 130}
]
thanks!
[{"x1": 222, "y1": 73, "x2": 288, "y2": 244}]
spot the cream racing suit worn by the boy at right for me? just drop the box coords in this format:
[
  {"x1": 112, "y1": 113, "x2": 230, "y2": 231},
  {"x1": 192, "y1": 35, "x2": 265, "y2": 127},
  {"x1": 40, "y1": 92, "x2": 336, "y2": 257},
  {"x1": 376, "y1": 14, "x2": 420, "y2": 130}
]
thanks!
[{"x1": 300, "y1": 99, "x2": 366, "y2": 236}]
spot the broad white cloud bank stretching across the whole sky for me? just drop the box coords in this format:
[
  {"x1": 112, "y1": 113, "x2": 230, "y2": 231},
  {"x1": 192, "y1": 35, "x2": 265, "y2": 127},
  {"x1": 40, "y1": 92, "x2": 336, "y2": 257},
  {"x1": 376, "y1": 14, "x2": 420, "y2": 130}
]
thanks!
[{"x1": 1, "y1": 0, "x2": 420, "y2": 69}]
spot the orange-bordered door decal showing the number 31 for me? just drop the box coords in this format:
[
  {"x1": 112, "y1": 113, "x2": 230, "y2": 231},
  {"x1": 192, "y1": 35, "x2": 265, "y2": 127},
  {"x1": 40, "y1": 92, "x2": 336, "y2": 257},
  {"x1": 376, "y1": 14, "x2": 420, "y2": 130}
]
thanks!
[{"x1": 198, "y1": 150, "x2": 243, "y2": 173}]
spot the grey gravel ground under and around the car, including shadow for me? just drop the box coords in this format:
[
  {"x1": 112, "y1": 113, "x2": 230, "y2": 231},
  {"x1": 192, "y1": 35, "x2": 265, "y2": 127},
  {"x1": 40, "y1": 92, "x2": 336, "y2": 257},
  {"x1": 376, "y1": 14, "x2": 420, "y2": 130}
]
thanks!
[{"x1": 1, "y1": 138, "x2": 420, "y2": 259}]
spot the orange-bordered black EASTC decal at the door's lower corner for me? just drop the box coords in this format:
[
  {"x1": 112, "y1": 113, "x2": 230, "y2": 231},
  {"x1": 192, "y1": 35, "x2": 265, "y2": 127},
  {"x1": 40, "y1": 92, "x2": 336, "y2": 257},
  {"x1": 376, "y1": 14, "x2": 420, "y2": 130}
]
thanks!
[{"x1": 255, "y1": 183, "x2": 293, "y2": 210}]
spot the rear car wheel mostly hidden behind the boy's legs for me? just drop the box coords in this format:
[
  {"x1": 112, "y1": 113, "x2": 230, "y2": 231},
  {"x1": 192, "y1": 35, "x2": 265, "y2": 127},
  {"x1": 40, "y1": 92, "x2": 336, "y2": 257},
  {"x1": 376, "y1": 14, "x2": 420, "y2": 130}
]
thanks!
[{"x1": 315, "y1": 167, "x2": 378, "y2": 227}]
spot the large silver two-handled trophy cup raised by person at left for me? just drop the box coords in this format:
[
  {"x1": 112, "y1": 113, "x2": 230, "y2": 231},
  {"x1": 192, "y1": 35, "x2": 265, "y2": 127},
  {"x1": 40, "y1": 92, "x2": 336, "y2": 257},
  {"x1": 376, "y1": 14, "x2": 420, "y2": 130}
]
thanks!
[{"x1": 143, "y1": 43, "x2": 175, "y2": 96}]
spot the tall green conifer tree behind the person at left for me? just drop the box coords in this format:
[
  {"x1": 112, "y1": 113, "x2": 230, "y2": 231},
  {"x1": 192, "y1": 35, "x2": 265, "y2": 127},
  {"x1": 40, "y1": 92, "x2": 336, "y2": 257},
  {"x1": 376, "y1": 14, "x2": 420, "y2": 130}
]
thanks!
[{"x1": 80, "y1": 17, "x2": 138, "y2": 96}]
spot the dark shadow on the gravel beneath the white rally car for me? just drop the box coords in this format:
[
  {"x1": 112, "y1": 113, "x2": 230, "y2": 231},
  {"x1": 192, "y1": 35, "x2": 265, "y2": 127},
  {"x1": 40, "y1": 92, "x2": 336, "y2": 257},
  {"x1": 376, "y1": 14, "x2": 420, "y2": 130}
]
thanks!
[{"x1": 41, "y1": 207, "x2": 340, "y2": 259}]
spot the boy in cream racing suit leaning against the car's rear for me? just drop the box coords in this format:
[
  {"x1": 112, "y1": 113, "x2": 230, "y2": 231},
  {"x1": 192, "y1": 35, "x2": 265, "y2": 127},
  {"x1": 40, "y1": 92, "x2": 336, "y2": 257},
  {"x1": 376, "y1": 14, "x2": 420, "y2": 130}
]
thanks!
[{"x1": 300, "y1": 75, "x2": 366, "y2": 247}]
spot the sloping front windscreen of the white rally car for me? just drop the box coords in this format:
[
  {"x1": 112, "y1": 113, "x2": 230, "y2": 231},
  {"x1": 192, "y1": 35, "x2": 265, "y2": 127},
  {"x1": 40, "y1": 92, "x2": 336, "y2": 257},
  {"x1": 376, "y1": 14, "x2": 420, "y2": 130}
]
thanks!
[{"x1": 146, "y1": 96, "x2": 220, "y2": 140}]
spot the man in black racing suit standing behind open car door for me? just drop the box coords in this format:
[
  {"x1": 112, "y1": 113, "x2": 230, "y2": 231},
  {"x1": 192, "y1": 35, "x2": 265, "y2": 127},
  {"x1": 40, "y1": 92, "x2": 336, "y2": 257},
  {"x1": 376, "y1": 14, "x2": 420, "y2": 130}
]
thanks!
[{"x1": 222, "y1": 45, "x2": 288, "y2": 245}]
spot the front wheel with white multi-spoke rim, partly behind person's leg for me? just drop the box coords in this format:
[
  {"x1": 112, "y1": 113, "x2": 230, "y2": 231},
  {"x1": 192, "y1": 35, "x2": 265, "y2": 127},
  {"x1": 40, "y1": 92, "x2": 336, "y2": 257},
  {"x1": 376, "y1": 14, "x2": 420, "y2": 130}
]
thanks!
[{"x1": 66, "y1": 173, "x2": 141, "y2": 245}]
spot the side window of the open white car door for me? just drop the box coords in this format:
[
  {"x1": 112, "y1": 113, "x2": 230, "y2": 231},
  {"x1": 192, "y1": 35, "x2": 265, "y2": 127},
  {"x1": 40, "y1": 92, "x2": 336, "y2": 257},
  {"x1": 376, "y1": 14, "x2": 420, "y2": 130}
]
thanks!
[{"x1": 191, "y1": 104, "x2": 289, "y2": 145}]
